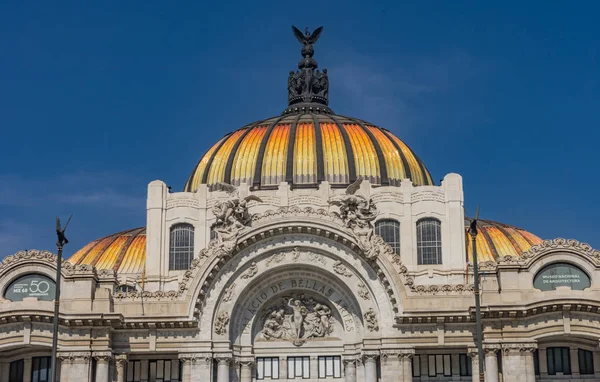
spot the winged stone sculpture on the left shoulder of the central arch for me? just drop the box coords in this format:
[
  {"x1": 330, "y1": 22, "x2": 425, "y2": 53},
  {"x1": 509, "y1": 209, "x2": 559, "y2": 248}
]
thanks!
[{"x1": 200, "y1": 183, "x2": 262, "y2": 257}]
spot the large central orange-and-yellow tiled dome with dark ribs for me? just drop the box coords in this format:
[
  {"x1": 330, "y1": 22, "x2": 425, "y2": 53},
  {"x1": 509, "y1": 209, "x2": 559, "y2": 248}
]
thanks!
[{"x1": 184, "y1": 112, "x2": 433, "y2": 192}]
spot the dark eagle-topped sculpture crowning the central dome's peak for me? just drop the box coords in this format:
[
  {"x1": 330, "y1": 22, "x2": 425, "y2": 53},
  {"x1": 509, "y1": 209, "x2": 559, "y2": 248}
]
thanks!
[{"x1": 286, "y1": 26, "x2": 331, "y2": 113}]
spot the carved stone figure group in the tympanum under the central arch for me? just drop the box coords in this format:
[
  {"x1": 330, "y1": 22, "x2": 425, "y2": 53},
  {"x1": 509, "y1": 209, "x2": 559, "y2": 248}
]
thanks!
[{"x1": 260, "y1": 295, "x2": 335, "y2": 346}]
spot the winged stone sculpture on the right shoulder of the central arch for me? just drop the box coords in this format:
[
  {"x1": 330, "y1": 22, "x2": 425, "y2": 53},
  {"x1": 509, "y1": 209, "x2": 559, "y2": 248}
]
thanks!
[{"x1": 329, "y1": 179, "x2": 384, "y2": 260}]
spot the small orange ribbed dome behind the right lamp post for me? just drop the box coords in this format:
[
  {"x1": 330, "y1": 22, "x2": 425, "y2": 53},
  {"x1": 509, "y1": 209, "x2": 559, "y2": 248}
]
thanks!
[{"x1": 465, "y1": 218, "x2": 542, "y2": 263}]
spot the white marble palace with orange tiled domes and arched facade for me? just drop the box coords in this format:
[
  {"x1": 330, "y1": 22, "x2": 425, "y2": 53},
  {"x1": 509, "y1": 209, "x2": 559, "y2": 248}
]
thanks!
[{"x1": 0, "y1": 26, "x2": 600, "y2": 382}]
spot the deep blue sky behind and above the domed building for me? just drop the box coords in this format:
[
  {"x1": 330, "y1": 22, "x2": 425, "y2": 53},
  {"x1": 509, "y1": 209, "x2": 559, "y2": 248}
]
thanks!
[{"x1": 0, "y1": 1, "x2": 600, "y2": 257}]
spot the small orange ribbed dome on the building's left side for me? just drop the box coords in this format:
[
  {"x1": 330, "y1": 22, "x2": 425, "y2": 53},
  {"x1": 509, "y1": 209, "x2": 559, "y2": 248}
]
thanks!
[{"x1": 67, "y1": 227, "x2": 146, "y2": 274}]
